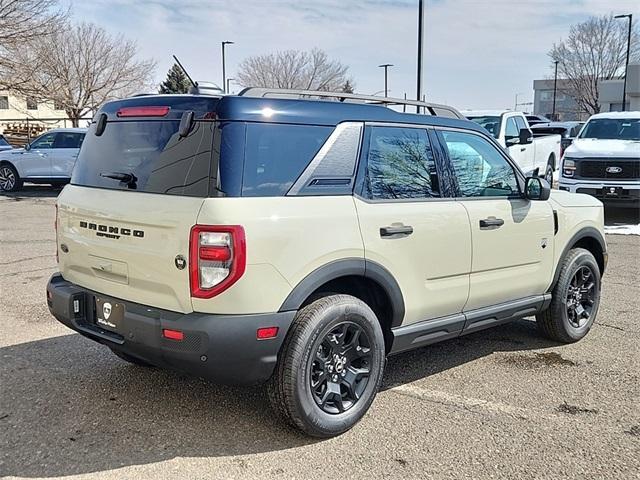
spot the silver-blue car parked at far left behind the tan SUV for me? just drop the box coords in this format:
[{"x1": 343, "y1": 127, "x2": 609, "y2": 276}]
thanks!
[{"x1": 0, "y1": 128, "x2": 87, "y2": 192}]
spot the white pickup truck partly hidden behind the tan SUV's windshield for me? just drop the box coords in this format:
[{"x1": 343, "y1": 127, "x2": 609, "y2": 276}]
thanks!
[{"x1": 462, "y1": 110, "x2": 561, "y2": 185}]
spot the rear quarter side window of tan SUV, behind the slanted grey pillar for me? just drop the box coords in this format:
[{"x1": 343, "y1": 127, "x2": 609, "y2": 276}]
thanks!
[{"x1": 242, "y1": 123, "x2": 333, "y2": 197}]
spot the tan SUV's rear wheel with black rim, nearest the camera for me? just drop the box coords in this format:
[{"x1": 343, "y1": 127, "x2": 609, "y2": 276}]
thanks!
[{"x1": 267, "y1": 295, "x2": 385, "y2": 437}]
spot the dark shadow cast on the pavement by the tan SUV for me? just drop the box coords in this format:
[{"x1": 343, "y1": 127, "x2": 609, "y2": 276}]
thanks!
[{"x1": 0, "y1": 321, "x2": 551, "y2": 477}]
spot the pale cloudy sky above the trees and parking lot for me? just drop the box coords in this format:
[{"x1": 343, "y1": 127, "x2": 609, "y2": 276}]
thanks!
[{"x1": 67, "y1": 0, "x2": 640, "y2": 109}]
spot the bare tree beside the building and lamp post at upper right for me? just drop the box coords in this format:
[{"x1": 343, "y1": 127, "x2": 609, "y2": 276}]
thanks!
[{"x1": 549, "y1": 15, "x2": 640, "y2": 114}]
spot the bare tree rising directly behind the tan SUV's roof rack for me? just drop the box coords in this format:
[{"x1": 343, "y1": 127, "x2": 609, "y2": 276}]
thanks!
[{"x1": 236, "y1": 48, "x2": 353, "y2": 92}]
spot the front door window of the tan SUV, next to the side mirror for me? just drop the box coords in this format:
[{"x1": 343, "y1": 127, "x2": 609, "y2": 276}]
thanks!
[{"x1": 442, "y1": 131, "x2": 520, "y2": 197}]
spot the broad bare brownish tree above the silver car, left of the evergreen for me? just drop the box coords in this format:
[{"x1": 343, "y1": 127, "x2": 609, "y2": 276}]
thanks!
[{"x1": 3, "y1": 23, "x2": 155, "y2": 126}]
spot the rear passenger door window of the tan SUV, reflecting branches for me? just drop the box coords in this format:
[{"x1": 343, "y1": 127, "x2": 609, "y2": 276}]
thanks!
[{"x1": 365, "y1": 127, "x2": 440, "y2": 199}]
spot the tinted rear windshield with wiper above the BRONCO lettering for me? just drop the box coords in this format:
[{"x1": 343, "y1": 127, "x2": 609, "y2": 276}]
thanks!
[{"x1": 71, "y1": 120, "x2": 215, "y2": 197}]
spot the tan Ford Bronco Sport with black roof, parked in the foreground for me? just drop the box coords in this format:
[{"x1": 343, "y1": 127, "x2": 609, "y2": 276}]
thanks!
[{"x1": 47, "y1": 89, "x2": 607, "y2": 437}]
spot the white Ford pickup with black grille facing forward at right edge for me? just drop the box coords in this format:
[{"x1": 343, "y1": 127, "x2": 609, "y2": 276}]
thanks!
[{"x1": 559, "y1": 112, "x2": 640, "y2": 209}]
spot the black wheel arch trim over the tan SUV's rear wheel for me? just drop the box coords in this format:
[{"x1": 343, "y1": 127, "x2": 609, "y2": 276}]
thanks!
[{"x1": 279, "y1": 258, "x2": 405, "y2": 327}]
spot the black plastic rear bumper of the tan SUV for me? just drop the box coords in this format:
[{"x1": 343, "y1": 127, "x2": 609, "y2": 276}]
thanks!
[{"x1": 47, "y1": 274, "x2": 295, "y2": 385}]
